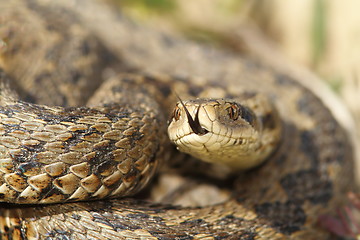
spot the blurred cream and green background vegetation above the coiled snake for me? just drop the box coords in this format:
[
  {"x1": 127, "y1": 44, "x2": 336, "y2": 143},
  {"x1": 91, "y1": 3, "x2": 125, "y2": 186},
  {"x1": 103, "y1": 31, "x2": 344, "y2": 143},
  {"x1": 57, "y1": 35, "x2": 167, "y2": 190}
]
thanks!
[{"x1": 107, "y1": 0, "x2": 360, "y2": 125}]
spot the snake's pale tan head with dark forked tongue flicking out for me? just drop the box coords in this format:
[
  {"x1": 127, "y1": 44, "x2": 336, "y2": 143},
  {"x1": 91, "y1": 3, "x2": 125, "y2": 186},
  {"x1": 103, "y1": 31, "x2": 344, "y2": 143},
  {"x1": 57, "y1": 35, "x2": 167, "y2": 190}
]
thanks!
[{"x1": 168, "y1": 96, "x2": 279, "y2": 169}]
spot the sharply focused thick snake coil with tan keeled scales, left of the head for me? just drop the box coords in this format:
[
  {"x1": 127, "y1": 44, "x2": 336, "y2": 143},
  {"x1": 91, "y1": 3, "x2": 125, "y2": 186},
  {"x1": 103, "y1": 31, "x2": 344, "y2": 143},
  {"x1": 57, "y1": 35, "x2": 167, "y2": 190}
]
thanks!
[{"x1": 0, "y1": 99, "x2": 160, "y2": 203}]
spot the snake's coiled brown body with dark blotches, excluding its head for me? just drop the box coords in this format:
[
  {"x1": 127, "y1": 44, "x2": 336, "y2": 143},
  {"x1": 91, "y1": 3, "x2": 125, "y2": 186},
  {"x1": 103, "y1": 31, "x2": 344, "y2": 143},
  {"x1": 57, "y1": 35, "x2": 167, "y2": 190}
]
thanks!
[{"x1": 0, "y1": 0, "x2": 354, "y2": 239}]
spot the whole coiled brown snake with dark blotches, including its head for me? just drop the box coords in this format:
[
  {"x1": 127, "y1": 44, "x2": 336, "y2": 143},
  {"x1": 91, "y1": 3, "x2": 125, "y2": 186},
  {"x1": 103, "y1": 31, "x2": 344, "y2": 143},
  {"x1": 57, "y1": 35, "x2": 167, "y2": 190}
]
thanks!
[{"x1": 0, "y1": 0, "x2": 355, "y2": 240}]
